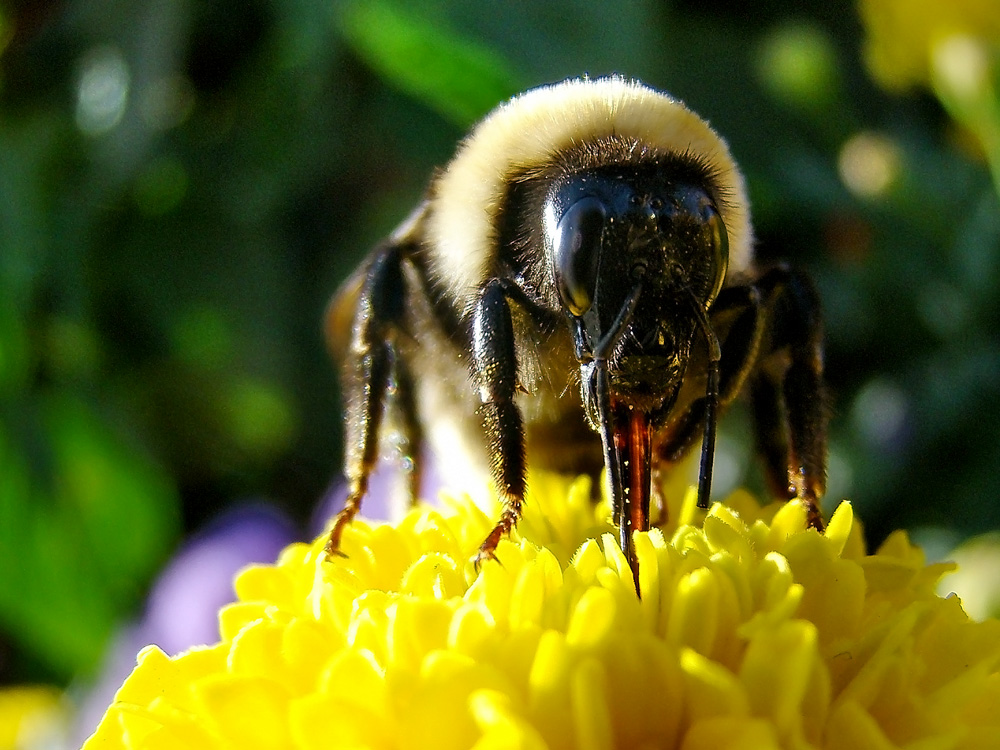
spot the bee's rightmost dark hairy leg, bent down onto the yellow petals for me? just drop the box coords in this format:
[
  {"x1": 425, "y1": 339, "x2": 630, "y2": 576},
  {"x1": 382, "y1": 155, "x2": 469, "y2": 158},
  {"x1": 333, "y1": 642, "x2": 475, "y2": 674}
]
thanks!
[{"x1": 751, "y1": 266, "x2": 829, "y2": 530}]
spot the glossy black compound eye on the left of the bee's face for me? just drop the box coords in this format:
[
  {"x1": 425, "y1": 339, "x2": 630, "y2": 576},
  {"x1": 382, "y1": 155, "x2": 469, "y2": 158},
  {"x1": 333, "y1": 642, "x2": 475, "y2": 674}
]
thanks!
[{"x1": 552, "y1": 196, "x2": 607, "y2": 317}]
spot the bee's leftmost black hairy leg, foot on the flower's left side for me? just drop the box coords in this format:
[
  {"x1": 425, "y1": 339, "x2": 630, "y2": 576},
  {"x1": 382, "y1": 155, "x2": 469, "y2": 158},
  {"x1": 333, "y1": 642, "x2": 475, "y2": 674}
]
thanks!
[{"x1": 325, "y1": 246, "x2": 405, "y2": 555}]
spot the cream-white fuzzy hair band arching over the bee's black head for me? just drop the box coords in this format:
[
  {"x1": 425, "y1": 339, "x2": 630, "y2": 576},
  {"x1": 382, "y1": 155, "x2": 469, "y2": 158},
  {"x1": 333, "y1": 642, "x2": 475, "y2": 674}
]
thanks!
[{"x1": 426, "y1": 76, "x2": 753, "y2": 312}]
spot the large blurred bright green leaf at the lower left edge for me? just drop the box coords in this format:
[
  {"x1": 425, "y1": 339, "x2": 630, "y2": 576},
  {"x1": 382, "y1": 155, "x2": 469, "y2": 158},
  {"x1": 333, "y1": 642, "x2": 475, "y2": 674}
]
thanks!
[{"x1": 0, "y1": 394, "x2": 178, "y2": 675}]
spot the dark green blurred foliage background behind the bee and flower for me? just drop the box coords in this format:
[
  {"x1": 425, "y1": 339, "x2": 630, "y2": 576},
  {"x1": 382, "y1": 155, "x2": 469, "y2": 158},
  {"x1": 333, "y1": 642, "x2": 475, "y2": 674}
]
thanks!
[{"x1": 0, "y1": 0, "x2": 1000, "y2": 708}]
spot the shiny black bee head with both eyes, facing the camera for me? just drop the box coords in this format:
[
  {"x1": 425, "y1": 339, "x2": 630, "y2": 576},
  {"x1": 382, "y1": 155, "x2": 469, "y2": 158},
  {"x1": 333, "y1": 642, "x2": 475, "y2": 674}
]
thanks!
[{"x1": 543, "y1": 159, "x2": 729, "y2": 406}]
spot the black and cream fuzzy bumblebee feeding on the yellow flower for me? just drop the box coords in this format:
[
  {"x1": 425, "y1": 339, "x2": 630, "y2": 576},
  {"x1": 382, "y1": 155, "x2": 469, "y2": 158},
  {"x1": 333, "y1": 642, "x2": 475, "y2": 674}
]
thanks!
[{"x1": 327, "y1": 76, "x2": 827, "y2": 592}]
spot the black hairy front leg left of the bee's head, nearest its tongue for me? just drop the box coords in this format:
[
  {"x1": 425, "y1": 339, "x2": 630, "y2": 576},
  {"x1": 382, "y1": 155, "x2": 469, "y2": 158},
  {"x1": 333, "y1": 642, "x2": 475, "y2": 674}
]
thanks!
[{"x1": 472, "y1": 279, "x2": 526, "y2": 566}]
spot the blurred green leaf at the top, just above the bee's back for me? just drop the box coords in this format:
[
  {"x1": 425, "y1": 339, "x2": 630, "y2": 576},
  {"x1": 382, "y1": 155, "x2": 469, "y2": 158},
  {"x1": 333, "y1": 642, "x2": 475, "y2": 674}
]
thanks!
[{"x1": 340, "y1": 0, "x2": 523, "y2": 126}]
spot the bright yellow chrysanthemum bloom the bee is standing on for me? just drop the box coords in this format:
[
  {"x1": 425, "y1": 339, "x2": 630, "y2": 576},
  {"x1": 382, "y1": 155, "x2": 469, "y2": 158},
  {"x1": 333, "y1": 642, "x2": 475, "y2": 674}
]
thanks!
[{"x1": 85, "y1": 476, "x2": 1000, "y2": 750}]
